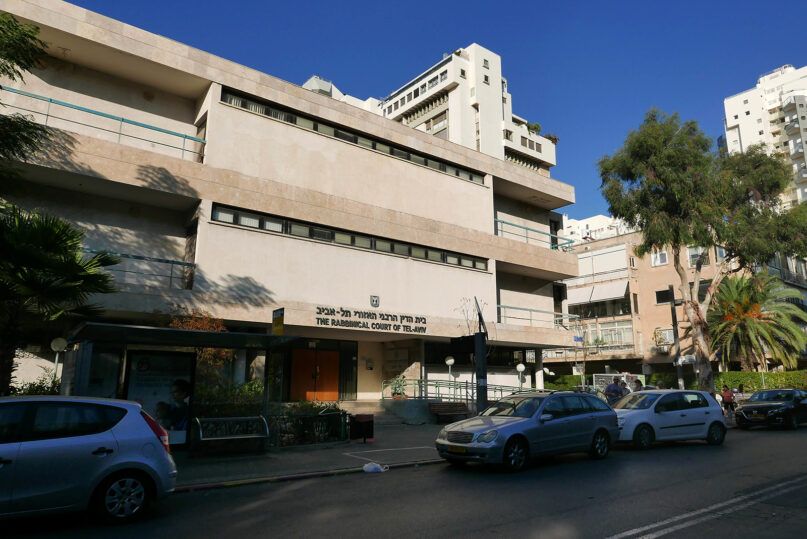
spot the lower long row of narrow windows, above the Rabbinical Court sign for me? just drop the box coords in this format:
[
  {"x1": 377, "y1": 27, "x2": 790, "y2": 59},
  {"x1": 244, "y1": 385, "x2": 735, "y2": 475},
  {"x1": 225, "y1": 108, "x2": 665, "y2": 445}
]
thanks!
[{"x1": 213, "y1": 205, "x2": 488, "y2": 270}]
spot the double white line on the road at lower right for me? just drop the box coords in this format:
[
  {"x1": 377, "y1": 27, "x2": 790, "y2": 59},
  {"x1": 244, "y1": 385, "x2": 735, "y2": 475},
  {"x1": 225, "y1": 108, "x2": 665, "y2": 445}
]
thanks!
[{"x1": 608, "y1": 477, "x2": 807, "y2": 539}]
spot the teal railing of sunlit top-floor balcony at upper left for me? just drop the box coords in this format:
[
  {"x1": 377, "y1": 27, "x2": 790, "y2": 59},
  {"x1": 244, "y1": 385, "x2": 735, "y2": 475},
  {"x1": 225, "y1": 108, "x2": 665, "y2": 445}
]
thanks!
[{"x1": 0, "y1": 86, "x2": 207, "y2": 162}]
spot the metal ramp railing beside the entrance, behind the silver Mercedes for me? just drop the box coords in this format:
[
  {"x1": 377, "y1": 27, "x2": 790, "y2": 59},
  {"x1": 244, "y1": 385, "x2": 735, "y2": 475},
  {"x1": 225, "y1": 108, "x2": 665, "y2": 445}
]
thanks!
[{"x1": 381, "y1": 378, "x2": 529, "y2": 402}]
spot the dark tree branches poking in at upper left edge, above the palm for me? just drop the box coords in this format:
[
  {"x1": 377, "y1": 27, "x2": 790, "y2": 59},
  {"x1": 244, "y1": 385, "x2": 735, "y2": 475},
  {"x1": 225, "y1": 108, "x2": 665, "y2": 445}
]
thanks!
[{"x1": 0, "y1": 13, "x2": 51, "y2": 186}]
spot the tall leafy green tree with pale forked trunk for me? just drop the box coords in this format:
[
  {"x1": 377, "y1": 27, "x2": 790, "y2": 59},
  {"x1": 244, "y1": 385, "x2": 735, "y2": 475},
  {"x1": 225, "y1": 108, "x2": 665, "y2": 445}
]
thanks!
[{"x1": 599, "y1": 109, "x2": 807, "y2": 391}]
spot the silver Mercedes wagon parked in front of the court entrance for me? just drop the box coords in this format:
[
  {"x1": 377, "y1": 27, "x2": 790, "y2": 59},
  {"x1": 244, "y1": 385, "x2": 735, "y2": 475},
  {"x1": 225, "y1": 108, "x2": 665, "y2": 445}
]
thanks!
[{"x1": 435, "y1": 391, "x2": 619, "y2": 471}]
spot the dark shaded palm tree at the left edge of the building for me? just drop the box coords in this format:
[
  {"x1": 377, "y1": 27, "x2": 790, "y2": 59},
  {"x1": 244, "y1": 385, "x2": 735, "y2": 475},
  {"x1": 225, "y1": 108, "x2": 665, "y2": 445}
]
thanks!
[{"x1": 0, "y1": 205, "x2": 120, "y2": 396}]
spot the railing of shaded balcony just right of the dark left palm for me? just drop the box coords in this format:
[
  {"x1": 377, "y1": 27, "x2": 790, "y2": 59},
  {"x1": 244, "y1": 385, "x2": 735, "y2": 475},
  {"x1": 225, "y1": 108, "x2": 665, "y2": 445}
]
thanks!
[{"x1": 83, "y1": 249, "x2": 196, "y2": 290}]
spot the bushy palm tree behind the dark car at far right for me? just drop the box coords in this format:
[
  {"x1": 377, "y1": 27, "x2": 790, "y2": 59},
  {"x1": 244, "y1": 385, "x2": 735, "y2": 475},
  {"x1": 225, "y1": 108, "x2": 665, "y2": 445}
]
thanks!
[{"x1": 708, "y1": 273, "x2": 807, "y2": 370}]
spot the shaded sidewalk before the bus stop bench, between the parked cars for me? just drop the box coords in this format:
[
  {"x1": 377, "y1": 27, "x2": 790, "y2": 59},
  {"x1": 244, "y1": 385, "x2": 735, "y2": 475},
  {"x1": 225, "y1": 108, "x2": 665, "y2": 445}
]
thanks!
[{"x1": 174, "y1": 423, "x2": 443, "y2": 492}]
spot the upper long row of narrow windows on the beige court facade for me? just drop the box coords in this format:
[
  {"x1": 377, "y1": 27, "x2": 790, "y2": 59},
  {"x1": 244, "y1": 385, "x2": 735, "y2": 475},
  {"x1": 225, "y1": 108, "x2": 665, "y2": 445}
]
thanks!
[{"x1": 221, "y1": 91, "x2": 484, "y2": 184}]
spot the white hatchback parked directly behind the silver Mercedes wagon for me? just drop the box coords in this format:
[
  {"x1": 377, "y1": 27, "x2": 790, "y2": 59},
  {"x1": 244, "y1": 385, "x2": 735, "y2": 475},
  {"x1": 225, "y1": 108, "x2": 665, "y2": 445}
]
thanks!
[{"x1": 614, "y1": 389, "x2": 726, "y2": 449}]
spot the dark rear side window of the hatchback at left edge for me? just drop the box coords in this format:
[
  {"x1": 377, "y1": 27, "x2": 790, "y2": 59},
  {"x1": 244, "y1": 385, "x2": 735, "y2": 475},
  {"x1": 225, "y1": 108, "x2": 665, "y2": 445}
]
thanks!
[{"x1": 25, "y1": 402, "x2": 126, "y2": 441}]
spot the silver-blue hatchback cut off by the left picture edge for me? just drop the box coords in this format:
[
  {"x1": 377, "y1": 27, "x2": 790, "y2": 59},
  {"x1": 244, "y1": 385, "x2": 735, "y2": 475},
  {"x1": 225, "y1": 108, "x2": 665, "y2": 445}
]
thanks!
[{"x1": 0, "y1": 397, "x2": 177, "y2": 522}]
